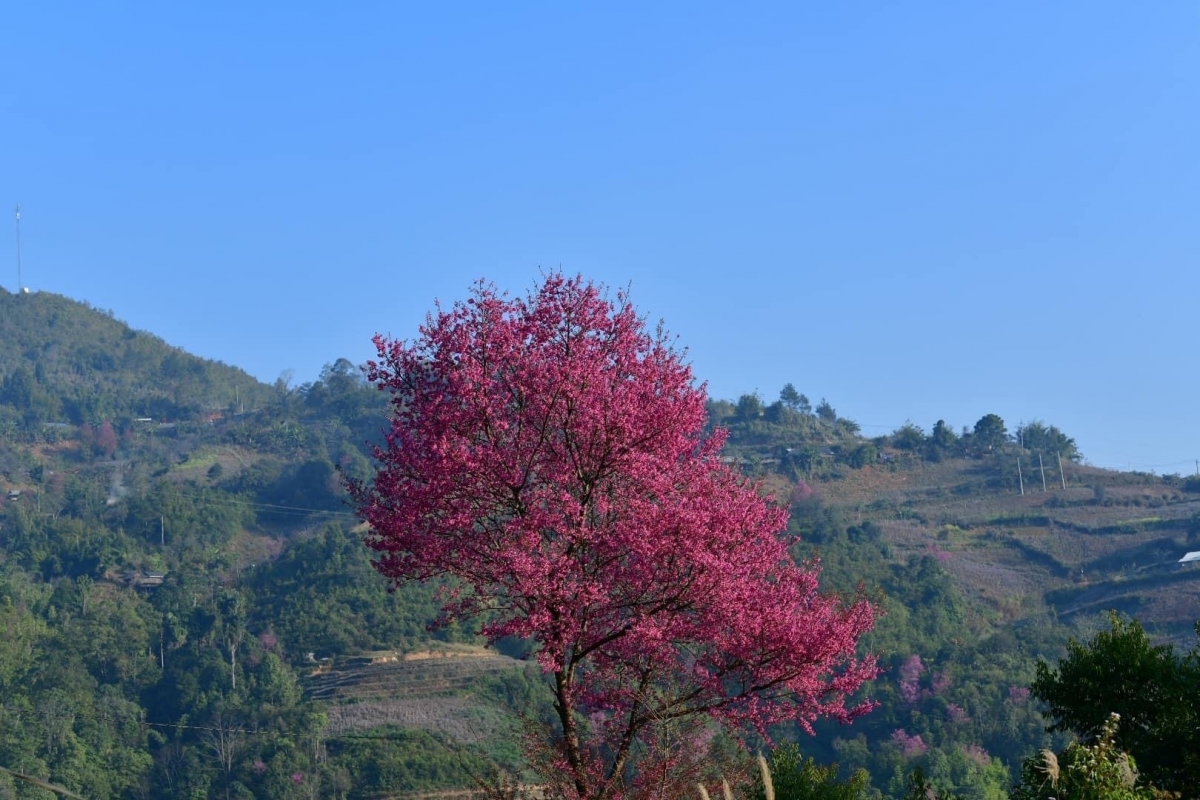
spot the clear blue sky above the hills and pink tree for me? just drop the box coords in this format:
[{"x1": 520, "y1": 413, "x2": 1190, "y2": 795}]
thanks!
[{"x1": 0, "y1": 1, "x2": 1200, "y2": 473}]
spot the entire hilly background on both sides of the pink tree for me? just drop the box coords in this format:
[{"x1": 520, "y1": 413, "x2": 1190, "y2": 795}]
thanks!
[{"x1": 0, "y1": 293, "x2": 1200, "y2": 798}]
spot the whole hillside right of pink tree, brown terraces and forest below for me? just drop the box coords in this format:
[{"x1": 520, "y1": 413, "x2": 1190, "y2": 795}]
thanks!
[{"x1": 710, "y1": 385, "x2": 1200, "y2": 798}]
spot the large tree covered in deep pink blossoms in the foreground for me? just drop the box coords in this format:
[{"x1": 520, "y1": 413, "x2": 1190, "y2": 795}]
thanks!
[{"x1": 352, "y1": 275, "x2": 877, "y2": 799}]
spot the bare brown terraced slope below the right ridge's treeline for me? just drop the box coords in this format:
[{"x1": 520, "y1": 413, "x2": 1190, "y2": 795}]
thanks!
[{"x1": 814, "y1": 459, "x2": 1200, "y2": 643}]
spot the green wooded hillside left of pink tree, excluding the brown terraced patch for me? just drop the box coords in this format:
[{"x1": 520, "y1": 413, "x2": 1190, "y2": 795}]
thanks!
[{"x1": 0, "y1": 293, "x2": 487, "y2": 798}]
